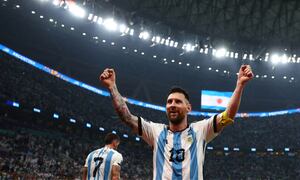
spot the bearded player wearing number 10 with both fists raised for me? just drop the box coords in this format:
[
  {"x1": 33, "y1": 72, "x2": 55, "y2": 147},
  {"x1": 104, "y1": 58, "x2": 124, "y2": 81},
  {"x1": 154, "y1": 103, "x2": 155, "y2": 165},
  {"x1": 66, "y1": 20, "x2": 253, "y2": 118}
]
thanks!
[{"x1": 100, "y1": 65, "x2": 253, "y2": 180}]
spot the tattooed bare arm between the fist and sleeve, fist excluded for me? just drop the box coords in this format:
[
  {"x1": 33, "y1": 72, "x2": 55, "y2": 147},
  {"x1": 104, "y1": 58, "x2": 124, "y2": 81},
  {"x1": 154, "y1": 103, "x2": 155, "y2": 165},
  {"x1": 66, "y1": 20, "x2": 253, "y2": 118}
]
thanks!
[{"x1": 110, "y1": 86, "x2": 138, "y2": 132}]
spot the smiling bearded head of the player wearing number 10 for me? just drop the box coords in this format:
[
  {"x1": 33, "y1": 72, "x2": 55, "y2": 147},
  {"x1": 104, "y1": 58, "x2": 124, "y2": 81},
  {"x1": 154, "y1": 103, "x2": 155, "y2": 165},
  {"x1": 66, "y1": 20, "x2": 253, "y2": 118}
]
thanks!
[{"x1": 166, "y1": 87, "x2": 192, "y2": 125}]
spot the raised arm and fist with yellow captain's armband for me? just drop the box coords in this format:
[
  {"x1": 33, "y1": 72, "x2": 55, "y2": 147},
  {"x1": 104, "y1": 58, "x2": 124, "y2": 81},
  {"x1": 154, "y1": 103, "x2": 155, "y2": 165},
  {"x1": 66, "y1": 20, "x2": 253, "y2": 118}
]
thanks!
[{"x1": 216, "y1": 65, "x2": 254, "y2": 132}]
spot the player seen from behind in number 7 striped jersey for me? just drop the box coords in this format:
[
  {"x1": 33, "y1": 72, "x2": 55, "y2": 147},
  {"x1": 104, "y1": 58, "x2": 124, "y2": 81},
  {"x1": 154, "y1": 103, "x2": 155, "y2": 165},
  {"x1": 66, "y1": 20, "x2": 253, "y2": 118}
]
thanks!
[{"x1": 82, "y1": 133, "x2": 123, "y2": 180}]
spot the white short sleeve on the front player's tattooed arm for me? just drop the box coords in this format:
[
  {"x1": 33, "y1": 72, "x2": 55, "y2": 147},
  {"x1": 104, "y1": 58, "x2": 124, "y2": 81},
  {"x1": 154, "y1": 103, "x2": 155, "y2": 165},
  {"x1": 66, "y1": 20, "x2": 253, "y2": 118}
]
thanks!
[{"x1": 138, "y1": 117, "x2": 165, "y2": 146}]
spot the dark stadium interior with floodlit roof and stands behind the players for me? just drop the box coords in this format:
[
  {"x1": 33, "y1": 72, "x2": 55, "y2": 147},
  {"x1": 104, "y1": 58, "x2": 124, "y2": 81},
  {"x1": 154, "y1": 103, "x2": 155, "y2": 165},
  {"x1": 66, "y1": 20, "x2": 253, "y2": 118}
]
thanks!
[{"x1": 0, "y1": 0, "x2": 300, "y2": 179}]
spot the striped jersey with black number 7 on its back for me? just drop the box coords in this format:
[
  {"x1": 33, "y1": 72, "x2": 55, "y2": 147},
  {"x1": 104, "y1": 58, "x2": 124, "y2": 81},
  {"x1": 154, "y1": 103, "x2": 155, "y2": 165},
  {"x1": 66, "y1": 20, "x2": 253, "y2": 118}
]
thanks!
[{"x1": 84, "y1": 147, "x2": 123, "y2": 180}]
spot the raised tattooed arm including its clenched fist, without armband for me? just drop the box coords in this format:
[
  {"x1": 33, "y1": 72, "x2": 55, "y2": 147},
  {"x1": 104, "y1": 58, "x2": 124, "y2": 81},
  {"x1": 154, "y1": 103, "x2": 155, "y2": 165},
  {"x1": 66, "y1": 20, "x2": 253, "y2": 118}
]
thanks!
[{"x1": 99, "y1": 68, "x2": 138, "y2": 133}]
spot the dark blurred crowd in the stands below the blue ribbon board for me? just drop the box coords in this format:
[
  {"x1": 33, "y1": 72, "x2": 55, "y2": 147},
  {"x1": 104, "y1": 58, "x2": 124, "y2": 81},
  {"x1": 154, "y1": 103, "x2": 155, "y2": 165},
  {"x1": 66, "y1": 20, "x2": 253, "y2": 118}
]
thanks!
[{"x1": 0, "y1": 54, "x2": 300, "y2": 179}]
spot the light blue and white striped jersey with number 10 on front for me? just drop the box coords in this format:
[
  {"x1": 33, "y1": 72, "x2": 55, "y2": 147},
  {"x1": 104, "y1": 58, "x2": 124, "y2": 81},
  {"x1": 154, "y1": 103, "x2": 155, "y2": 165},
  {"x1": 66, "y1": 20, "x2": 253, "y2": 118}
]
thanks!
[{"x1": 139, "y1": 116, "x2": 218, "y2": 180}]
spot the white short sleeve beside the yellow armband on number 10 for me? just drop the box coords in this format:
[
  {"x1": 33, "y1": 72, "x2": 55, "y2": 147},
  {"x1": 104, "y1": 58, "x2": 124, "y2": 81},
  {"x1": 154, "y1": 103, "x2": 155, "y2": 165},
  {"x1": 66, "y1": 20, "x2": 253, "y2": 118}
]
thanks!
[{"x1": 192, "y1": 114, "x2": 219, "y2": 143}]
